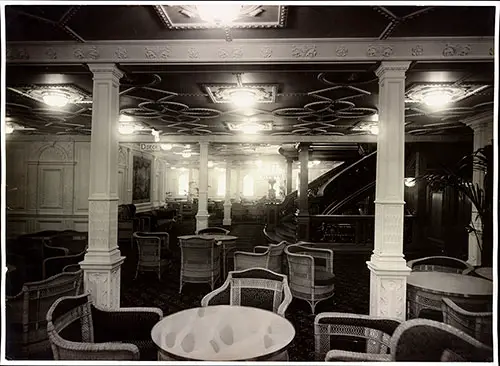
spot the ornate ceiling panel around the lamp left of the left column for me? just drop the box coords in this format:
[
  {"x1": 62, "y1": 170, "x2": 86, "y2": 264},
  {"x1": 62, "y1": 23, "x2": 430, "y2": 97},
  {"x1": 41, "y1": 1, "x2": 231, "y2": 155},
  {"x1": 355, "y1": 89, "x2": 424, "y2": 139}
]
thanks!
[{"x1": 8, "y1": 84, "x2": 92, "y2": 104}]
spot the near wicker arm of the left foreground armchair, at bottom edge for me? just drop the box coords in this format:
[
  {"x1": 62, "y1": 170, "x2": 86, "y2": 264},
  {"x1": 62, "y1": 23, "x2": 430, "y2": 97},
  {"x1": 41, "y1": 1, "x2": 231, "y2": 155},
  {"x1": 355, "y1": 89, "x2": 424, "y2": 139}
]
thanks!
[{"x1": 51, "y1": 336, "x2": 140, "y2": 360}]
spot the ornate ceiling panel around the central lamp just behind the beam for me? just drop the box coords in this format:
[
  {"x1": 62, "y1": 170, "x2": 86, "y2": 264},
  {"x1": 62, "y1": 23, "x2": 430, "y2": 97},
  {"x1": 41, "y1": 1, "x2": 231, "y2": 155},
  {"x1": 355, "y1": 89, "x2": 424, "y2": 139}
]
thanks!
[{"x1": 203, "y1": 84, "x2": 278, "y2": 103}]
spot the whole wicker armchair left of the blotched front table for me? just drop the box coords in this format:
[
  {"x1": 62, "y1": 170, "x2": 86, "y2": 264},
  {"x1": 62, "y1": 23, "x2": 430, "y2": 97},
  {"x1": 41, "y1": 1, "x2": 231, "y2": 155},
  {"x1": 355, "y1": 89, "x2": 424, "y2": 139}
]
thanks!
[{"x1": 47, "y1": 294, "x2": 163, "y2": 361}]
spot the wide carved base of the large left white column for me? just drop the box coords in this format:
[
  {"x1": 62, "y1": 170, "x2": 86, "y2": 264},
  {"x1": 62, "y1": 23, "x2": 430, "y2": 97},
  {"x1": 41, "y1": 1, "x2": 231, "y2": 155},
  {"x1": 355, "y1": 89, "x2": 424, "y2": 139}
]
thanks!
[{"x1": 80, "y1": 249, "x2": 125, "y2": 309}]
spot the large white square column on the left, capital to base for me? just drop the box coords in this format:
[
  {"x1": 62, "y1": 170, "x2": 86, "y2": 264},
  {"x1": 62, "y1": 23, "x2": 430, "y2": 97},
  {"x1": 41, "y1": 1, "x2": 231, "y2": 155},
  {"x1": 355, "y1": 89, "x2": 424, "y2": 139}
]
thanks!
[{"x1": 80, "y1": 64, "x2": 125, "y2": 309}]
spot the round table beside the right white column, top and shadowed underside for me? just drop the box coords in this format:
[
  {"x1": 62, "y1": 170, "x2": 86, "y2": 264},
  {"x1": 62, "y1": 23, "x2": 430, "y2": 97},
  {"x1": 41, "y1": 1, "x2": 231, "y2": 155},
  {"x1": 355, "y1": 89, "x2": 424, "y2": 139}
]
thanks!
[{"x1": 407, "y1": 272, "x2": 493, "y2": 318}]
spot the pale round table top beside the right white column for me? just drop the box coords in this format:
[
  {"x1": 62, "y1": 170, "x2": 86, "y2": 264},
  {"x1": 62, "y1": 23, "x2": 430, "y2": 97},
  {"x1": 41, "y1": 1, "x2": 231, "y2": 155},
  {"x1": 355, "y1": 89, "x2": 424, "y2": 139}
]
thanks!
[{"x1": 407, "y1": 272, "x2": 493, "y2": 297}]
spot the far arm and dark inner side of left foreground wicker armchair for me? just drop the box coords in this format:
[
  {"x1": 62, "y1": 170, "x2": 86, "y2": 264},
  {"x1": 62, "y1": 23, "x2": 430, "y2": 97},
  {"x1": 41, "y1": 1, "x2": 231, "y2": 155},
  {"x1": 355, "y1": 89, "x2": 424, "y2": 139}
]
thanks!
[{"x1": 92, "y1": 305, "x2": 163, "y2": 343}]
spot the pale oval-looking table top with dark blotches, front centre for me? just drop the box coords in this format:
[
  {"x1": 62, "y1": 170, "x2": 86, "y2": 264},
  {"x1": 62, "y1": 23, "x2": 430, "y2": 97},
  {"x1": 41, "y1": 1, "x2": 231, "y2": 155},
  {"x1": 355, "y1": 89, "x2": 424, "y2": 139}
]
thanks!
[{"x1": 151, "y1": 305, "x2": 295, "y2": 361}]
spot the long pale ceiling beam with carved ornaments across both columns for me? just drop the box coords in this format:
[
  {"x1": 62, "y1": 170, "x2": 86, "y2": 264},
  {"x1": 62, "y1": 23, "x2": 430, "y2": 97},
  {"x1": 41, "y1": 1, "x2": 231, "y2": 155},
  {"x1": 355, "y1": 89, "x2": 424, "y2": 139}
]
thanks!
[{"x1": 6, "y1": 37, "x2": 495, "y2": 64}]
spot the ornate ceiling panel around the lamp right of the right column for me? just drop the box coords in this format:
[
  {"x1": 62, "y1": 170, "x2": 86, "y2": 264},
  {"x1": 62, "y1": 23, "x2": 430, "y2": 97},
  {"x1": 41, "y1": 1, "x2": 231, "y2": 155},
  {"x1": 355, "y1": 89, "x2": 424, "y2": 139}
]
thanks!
[{"x1": 406, "y1": 83, "x2": 490, "y2": 103}]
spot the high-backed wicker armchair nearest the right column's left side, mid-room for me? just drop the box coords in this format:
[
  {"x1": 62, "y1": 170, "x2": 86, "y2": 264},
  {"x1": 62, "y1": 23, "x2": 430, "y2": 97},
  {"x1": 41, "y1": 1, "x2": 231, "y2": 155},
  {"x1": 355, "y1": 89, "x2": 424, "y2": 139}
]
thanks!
[{"x1": 285, "y1": 244, "x2": 335, "y2": 314}]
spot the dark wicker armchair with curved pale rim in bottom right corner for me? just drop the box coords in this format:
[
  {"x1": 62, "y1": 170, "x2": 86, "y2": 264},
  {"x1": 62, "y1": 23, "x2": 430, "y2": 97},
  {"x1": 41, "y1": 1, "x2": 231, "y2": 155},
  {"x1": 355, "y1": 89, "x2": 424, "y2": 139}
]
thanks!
[{"x1": 390, "y1": 319, "x2": 493, "y2": 362}]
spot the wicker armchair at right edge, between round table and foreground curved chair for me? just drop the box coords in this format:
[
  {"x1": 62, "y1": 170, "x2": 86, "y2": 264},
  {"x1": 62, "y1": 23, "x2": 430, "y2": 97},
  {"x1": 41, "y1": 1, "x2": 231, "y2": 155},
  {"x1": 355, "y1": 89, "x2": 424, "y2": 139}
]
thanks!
[{"x1": 442, "y1": 298, "x2": 493, "y2": 346}]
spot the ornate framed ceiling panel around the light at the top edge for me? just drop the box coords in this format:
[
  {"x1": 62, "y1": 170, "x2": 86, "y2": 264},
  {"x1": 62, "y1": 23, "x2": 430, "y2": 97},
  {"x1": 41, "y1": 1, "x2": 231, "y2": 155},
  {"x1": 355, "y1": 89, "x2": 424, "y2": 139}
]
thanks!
[{"x1": 154, "y1": 4, "x2": 287, "y2": 29}]
